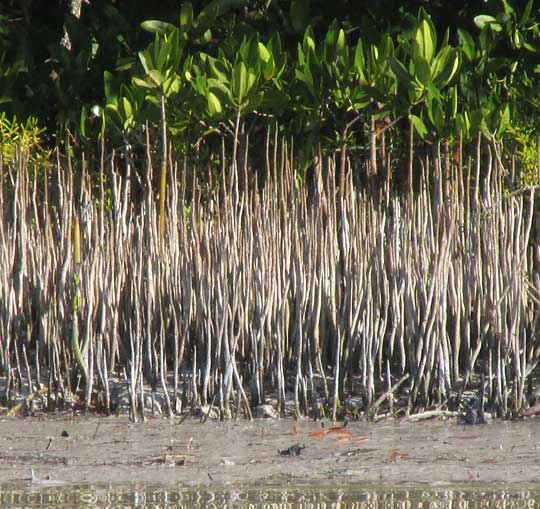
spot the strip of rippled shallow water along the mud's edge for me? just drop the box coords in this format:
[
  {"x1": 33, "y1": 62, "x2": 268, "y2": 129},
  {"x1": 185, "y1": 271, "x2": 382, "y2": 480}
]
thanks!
[{"x1": 0, "y1": 486, "x2": 540, "y2": 509}]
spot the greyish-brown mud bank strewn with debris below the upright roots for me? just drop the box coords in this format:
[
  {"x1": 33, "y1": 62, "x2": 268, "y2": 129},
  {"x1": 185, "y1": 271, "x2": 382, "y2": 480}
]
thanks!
[{"x1": 0, "y1": 415, "x2": 540, "y2": 486}]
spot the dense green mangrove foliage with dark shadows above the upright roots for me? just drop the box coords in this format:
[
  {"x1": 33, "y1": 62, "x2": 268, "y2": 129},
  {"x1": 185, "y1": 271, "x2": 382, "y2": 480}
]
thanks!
[{"x1": 0, "y1": 0, "x2": 540, "y2": 184}]
